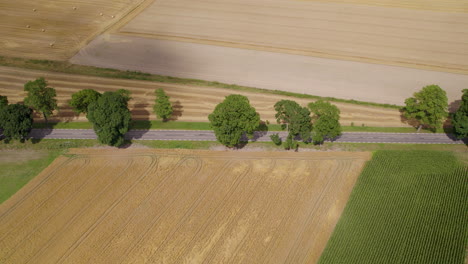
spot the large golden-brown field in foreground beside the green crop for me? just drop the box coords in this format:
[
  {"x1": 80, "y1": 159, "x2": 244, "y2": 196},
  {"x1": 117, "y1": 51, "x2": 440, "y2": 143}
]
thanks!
[{"x1": 0, "y1": 149, "x2": 370, "y2": 263}]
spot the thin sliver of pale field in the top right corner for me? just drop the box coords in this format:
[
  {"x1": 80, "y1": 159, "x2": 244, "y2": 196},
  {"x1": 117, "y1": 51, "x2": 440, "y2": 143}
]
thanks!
[{"x1": 304, "y1": 0, "x2": 468, "y2": 13}]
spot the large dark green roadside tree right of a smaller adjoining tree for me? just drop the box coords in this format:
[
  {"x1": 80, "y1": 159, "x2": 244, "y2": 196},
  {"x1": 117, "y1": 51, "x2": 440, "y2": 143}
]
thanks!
[{"x1": 87, "y1": 91, "x2": 131, "y2": 147}]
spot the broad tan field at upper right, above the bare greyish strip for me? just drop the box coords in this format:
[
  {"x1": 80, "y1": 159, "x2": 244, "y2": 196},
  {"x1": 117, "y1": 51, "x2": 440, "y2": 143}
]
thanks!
[{"x1": 119, "y1": 0, "x2": 468, "y2": 74}]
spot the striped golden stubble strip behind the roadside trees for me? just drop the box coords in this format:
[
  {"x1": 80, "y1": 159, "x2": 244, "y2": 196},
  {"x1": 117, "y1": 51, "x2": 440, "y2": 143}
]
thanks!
[{"x1": 0, "y1": 67, "x2": 407, "y2": 127}]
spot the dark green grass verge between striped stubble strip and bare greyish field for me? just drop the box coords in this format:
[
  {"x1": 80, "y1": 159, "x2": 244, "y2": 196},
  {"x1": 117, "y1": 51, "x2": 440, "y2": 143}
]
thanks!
[{"x1": 0, "y1": 56, "x2": 400, "y2": 109}]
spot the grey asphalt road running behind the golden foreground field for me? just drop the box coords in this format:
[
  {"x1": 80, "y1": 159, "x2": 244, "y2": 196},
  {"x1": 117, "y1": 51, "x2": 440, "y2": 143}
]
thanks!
[{"x1": 22, "y1": 129, "x2": 464, "y2": 144}]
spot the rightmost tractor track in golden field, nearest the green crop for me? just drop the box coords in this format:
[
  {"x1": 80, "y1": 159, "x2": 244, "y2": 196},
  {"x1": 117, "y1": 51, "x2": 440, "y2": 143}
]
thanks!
[{"x1": 286, "y1": 159, "x2": 350, "y2": 260}]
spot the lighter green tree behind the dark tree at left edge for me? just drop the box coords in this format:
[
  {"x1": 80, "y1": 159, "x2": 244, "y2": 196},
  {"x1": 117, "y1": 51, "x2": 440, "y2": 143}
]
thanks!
[{"x1": 24, "y1": 77, "x2": 58, "y2": 123}]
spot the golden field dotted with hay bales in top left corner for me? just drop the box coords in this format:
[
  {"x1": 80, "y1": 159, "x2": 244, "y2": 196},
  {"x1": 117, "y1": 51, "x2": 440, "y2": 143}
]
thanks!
[{"x1": 0, "y1": 0, "x2": 144, "y2": 60}]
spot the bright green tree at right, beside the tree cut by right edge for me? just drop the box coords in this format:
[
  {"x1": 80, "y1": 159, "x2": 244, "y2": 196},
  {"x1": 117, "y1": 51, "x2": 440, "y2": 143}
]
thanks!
[{"x1": 402, "y1": 85, "x2": 448, "y2": 132}]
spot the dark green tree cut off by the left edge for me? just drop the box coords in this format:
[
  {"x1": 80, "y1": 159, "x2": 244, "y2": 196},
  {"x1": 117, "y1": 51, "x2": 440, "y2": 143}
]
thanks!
[{"x1": 0, "y1": 104, "x2": 33, "y2": 140}]
